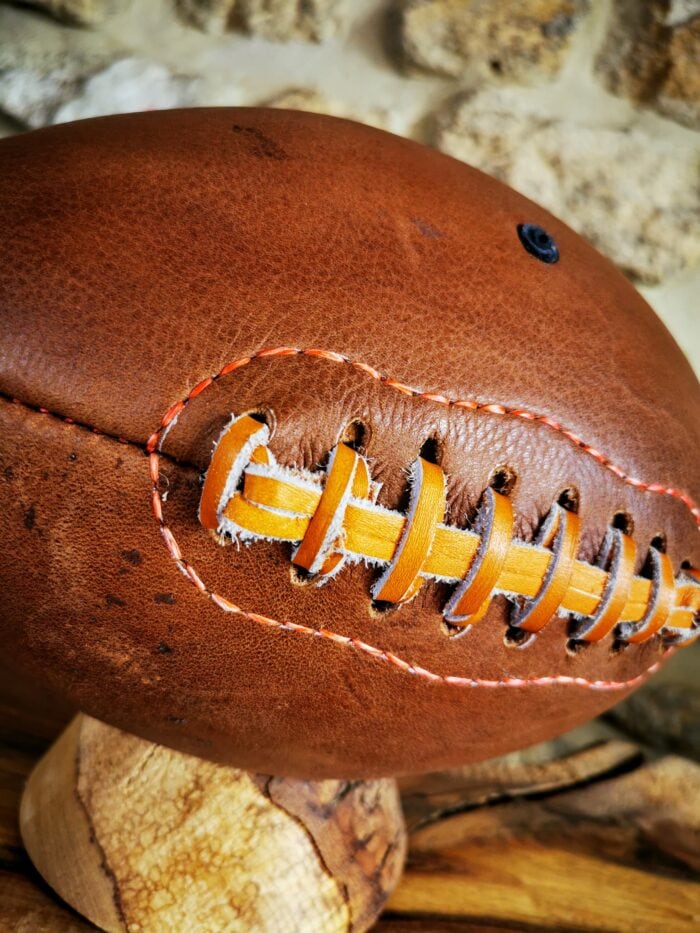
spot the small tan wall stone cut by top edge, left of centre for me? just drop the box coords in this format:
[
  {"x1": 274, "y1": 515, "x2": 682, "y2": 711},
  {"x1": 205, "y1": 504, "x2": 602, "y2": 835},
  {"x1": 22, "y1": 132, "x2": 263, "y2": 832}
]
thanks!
[{"x1": 235, "y1": 0, "x2": 349, "y2": 42}]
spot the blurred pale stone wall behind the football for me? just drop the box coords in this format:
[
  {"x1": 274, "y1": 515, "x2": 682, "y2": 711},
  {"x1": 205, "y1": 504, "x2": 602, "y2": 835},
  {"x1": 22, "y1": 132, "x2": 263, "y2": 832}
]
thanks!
[{"x1": 0, "y1": 0, "x2": 700, "y2": 371}]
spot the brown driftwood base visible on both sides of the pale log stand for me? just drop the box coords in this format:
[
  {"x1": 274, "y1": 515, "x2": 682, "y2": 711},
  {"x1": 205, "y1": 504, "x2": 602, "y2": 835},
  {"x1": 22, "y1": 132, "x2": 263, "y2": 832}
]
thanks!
[{"x1": 0, "y1": 649, "x2": 700, "y2": 933}]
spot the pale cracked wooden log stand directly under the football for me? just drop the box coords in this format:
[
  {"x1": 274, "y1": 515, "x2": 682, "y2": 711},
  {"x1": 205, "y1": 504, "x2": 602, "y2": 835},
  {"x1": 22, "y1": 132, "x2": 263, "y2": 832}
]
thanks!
[{"x1": 20, "y1": 715, "x2": 406, "y2": 933}]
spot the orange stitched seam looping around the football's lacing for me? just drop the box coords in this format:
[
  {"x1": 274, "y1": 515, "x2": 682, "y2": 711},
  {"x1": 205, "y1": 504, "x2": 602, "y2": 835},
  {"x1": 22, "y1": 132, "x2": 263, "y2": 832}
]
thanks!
[{"x1": 146, "y1": 347, "x2": 692, "y2": 691}]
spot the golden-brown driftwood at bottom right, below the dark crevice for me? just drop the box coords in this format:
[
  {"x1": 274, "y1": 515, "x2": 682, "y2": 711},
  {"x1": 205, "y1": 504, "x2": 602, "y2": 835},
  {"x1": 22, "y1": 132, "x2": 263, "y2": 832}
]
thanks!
[{"x1": 388, "y1": 749, "x2": 700, "y2": 931}]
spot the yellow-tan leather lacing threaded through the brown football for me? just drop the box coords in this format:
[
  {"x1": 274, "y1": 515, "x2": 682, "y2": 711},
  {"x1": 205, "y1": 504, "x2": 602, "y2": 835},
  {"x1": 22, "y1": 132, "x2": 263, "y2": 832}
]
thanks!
[{"x1": 200, "y1": 415, "x2": 700, "y2": 644}]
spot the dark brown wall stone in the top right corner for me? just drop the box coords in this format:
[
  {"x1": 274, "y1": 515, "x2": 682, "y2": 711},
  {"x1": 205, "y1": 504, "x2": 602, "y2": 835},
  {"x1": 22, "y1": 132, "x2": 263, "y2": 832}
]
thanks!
[{"x1": 596, "y1": 0, "x2": 700, "y2": 128}]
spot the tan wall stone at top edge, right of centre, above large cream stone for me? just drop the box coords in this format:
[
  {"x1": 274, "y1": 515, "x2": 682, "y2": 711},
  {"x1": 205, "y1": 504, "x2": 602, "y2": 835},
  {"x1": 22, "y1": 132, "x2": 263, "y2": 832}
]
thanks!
[{"x1": 398, "y1": 0, "x2": 589, "y2": 79}]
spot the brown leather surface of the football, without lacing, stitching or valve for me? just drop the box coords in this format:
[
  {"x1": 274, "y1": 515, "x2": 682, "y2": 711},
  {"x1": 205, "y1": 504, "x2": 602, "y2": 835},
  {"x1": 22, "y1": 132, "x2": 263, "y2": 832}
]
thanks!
[{"x1": 0, "y1": 109, "x2": 700, "y2": 778}]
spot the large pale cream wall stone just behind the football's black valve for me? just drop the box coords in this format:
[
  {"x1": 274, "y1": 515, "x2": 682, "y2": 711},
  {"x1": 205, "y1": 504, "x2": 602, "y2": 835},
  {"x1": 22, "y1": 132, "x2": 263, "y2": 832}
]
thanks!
[{"x1": 436, "y1": 89, "x2": 700, "y2": 283}]
